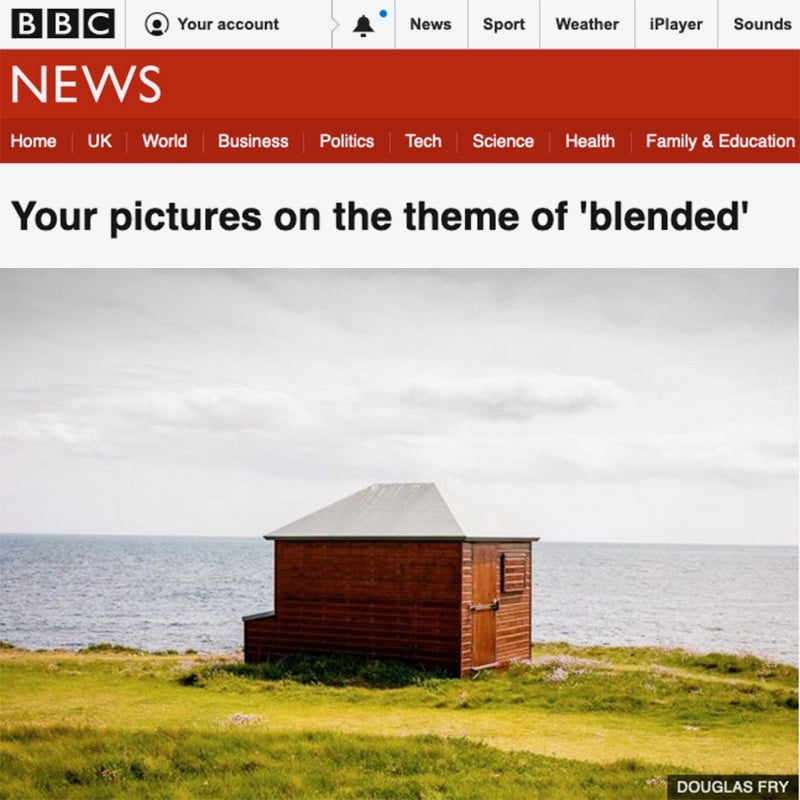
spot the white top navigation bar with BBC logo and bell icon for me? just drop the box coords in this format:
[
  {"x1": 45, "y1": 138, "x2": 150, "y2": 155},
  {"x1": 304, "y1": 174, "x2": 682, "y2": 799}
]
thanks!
[{"x1": 0, "y1": 0, "x2": 800, "y2": 50}]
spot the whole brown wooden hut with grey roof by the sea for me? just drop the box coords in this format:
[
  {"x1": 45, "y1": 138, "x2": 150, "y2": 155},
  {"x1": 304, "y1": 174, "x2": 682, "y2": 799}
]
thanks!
[{"x1": 244, "y1": 483, "x2": 536, "y2": 676}]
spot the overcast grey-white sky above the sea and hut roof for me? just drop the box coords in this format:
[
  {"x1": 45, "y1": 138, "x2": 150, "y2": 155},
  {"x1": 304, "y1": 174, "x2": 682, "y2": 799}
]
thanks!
[{"x1": 0, "y1": 270, "x2": 798, "y2": 544}]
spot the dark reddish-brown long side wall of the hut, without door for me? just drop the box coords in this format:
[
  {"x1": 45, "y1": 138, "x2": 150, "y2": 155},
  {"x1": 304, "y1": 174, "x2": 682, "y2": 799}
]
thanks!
[{"x1": 245, "y1": 540, "x2": 464, "y2": 674}]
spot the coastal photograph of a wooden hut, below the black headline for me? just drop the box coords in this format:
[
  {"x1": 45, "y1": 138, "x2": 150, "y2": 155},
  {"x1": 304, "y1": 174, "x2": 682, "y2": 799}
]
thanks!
[{"x1": 0, "y1": 268, "x2": 798, "y2": 800}]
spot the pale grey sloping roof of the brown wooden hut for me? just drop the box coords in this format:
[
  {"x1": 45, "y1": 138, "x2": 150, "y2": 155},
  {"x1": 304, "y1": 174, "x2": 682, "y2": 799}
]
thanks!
[{"x1": 265, "y1": 483, "x2": 466, "y2": 540}]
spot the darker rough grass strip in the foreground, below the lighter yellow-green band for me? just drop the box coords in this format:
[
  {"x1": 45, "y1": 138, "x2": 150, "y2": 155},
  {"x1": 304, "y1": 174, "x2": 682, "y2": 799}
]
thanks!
[{"x1": 2, "y1": 727, "x2": 680, "y2": 800}]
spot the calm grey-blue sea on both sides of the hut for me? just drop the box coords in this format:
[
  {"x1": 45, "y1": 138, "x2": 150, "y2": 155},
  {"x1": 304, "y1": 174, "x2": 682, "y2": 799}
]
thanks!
[{"x1": 0, "y1": 536, "x2": 798, "y2": 664}]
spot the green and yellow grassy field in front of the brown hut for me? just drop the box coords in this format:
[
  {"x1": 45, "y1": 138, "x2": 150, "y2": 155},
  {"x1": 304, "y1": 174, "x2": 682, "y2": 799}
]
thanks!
[{"x1": 0, "y1": 644, "x2": 798, "y2": 800}]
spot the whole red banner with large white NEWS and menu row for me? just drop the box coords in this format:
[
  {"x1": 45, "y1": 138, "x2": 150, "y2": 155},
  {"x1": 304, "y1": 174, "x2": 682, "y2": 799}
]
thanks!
[{"x1": 0, "y1": 50, "x2": 800, "y2": 162}]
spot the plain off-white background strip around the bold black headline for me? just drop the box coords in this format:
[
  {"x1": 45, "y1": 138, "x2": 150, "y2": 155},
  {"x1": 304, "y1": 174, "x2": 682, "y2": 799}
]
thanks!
[{"x1": 0, "y1": 164, "x2": 800, "y2": 267}]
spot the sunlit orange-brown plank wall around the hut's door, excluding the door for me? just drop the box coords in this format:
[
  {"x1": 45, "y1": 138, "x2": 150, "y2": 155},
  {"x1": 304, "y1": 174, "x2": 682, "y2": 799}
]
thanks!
[{"x1": 461, "y1": 542, "x2": 533, "y2": 675}]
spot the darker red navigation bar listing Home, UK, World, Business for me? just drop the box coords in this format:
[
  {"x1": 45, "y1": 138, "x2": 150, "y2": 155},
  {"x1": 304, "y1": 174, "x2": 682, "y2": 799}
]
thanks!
[{"x1": 0, "y1": 119, "x2": 800, "y2": 163}]
